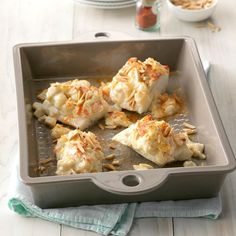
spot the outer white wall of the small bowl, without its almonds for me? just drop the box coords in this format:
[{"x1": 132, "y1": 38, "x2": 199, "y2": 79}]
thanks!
[{"x1": 167, "y1": 0, "x2": 218, "y2": 22}]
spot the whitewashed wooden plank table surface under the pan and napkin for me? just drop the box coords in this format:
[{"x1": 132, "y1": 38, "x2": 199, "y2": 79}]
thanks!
[{"x1": 0, "y1": 0, "x2": 236, "y2": 236}]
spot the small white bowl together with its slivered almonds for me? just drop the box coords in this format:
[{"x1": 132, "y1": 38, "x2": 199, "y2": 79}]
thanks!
[{"x1": 167, "y1": 0, "x2": 218, "y2": 22}]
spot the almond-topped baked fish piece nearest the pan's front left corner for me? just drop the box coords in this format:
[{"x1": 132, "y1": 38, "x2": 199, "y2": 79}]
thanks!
[{"x1": 54, "y1": 129, "x2": 104, "y2": 175}]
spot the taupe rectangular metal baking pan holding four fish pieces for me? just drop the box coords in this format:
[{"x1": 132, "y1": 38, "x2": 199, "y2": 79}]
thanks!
[{"x1": 14, "y1": 37, "x2": 235, "y2": 208}]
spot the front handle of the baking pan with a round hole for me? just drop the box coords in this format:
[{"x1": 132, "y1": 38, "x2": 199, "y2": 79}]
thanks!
[{"x1": 93, "y1": 169, "x2": 168, "y2": 195}]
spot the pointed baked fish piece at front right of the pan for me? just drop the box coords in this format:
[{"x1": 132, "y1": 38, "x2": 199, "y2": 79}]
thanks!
[{"x1": 113, "y1": 115, "x2": 192, "y2": 166}]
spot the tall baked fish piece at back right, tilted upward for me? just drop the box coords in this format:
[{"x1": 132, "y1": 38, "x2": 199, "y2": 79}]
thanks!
[{"x1": 107, "y1": 57, "x2": 169, "y2": 114}]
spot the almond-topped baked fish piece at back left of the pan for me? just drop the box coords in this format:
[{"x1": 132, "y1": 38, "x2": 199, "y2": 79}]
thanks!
[{"x1": 33, "y1": 79, "x2": 109, "y2": 130}]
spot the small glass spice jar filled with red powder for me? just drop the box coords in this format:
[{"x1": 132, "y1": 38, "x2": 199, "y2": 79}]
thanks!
[{"x1": 135, "y1": 0, "x2": 160, "y2": 31}]
